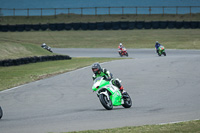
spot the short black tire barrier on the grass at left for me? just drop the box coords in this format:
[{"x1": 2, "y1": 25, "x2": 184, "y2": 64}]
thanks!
[{"x1": 0, "y1": 55, "x2": 71, "y2": 66}]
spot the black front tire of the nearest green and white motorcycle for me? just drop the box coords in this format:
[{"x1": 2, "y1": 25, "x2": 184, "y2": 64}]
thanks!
[{"x1": 99, "y1": 94, "x2": 113, "y2": 110}]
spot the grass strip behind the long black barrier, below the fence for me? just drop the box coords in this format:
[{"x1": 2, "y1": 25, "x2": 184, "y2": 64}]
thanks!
[{"x1": 0, "y1": 13, "x2": 200, "y2": 25}]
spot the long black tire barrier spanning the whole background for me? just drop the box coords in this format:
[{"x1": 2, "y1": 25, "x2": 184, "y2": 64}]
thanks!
[{"x1": 0, "y1": 21, "x2": 200, "y2": 32}]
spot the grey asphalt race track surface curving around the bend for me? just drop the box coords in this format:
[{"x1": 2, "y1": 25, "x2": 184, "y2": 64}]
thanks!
[{"x1": 0, "y1": 48, "x2": 200, "y2": 133}]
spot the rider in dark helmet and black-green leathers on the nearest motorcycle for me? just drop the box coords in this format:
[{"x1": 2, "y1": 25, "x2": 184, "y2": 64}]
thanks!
[{"x1": 92, "y1": 63, "x2": 125, "y2": 94}]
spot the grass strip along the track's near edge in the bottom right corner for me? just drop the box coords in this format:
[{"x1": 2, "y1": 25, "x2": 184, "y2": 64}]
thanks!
[{"x1": 68, "y1": 120, "x2": 200, "y2": 133}]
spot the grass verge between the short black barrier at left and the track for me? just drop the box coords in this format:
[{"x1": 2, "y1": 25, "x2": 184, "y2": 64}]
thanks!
[{"x1": 0, "y1": 58, "x2": 123, "y2": 91}]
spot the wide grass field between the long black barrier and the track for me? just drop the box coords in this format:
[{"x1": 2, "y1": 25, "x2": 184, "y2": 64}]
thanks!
[{"x1": 0, "y1": 29, "x2": 200, "y2": 55}]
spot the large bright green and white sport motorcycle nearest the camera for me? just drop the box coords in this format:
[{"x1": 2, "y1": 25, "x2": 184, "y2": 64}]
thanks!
[{"x1": 92, "y1": 77, "x2": 132, "y2": 110}]
